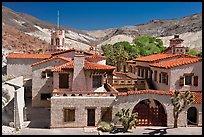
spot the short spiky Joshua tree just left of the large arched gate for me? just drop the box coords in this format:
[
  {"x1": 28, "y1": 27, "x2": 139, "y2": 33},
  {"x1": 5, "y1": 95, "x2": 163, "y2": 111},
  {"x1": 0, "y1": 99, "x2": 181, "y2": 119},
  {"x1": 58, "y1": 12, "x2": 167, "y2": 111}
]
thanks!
[{"x1": 115, "y1": 108, "x2": 138, "y2": 132}]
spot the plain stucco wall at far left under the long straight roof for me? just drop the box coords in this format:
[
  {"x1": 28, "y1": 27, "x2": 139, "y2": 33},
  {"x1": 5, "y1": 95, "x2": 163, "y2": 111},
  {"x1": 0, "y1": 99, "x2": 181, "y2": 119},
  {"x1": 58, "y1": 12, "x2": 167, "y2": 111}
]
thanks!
[{"x1": 7, "y1": 58, "x2": 43, "y2": 78}]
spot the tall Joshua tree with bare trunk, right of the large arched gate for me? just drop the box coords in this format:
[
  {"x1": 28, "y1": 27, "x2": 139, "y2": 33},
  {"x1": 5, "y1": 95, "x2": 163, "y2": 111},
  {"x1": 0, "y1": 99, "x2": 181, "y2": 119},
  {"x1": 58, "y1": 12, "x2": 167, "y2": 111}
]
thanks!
[{"x1": 171, "y1": 90, "x2": 194, "y2": 128}]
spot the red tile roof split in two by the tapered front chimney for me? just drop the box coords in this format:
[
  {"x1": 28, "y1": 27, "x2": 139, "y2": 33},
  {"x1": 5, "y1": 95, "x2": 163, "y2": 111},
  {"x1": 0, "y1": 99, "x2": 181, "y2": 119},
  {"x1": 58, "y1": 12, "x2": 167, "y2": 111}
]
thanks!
[{"x1": 52, "y1": 61, "x2": 115, "y2": 72}]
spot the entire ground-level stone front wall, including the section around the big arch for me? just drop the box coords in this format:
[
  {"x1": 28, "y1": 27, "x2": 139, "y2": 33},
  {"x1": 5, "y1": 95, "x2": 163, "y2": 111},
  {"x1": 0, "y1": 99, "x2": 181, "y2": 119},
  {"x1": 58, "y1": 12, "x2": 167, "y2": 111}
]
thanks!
[{"x1": 51, "y1": 94, "x2": 202, "y2": 128}]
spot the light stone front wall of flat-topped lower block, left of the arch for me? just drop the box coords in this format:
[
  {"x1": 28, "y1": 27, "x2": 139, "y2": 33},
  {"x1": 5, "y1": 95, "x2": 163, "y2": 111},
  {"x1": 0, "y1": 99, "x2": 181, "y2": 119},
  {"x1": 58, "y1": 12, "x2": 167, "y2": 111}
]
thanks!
[{"x1": 51, "y1": 97, "x2": 115, "y2": 128}]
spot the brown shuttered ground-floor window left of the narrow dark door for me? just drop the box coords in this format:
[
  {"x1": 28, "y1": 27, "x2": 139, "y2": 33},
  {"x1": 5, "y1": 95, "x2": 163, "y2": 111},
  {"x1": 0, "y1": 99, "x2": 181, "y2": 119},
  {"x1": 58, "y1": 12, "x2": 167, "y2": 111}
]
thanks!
[{"x1": 64, "y1": 108, "x2": 75, "y2": 122}]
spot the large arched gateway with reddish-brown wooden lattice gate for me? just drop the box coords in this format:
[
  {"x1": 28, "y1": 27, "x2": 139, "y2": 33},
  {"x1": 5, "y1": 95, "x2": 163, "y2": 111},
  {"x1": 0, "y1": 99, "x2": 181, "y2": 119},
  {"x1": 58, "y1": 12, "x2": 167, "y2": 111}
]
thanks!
[{"x1": 133, "y1": 99, "x2": 167, "y2": 126}]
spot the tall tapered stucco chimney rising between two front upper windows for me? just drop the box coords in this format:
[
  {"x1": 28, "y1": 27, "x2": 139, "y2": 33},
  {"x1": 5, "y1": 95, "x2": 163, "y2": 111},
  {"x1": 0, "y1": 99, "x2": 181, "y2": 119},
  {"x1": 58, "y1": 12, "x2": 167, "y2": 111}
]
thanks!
[{"x1": 72, "y1": 50, "x2": 86, "y2": 91}]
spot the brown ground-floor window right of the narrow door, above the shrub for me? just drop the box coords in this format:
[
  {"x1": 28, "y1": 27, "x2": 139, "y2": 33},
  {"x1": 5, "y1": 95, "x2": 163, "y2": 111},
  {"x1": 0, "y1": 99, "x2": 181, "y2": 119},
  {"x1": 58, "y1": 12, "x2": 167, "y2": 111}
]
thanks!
[{"x1": 101, "y1": 107, "x2": 112, "y2": 122}]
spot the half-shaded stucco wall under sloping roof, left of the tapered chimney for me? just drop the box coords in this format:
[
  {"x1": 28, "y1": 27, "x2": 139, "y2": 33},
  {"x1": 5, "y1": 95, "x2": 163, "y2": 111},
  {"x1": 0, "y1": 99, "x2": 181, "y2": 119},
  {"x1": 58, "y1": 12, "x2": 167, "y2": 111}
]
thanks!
[{"x1": 32, "y1": 59, "x2": 66, "y2": 107}]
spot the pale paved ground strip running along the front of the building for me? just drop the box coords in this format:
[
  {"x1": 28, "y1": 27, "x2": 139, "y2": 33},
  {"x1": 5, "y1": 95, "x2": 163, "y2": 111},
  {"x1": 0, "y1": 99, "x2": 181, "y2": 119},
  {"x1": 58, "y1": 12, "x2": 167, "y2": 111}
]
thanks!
[{"x1": 3, "y1": 127, "x2": 202, "y2": 135}]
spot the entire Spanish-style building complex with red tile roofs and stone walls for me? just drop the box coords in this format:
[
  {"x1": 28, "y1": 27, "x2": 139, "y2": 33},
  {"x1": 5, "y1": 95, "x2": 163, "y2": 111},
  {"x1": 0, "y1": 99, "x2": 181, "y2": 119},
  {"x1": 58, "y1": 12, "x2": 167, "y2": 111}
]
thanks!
[{"x1": 7, "y1": 29, "x2": 202, "y2": 128}]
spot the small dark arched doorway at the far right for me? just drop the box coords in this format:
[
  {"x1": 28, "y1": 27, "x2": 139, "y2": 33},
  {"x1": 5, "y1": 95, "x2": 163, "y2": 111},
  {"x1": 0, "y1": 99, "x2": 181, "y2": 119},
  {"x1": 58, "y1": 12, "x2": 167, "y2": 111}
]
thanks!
[{"x1": 187, "y1": 107, "x2": 197, "y2": 125}]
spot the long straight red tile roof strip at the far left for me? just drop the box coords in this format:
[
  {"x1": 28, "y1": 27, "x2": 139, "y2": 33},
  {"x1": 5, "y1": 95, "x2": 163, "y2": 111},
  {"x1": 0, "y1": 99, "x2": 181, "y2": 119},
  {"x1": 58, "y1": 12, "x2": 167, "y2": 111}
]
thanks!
[{"x1": 7, "y1": 53, "x2": 51, "y2": 59}]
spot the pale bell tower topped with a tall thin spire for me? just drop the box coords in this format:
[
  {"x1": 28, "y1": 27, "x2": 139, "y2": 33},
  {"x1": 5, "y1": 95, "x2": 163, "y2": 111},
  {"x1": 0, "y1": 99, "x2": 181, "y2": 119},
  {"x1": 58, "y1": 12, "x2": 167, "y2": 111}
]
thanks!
[{"x1": 49, "y1": 11, "x2": 65, "y2": 51}]
